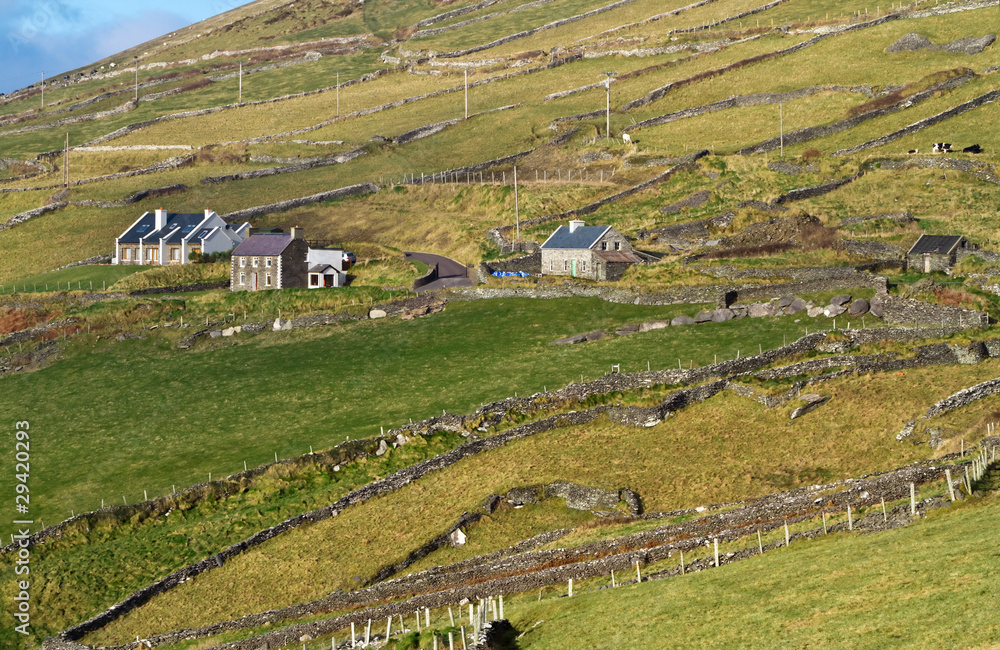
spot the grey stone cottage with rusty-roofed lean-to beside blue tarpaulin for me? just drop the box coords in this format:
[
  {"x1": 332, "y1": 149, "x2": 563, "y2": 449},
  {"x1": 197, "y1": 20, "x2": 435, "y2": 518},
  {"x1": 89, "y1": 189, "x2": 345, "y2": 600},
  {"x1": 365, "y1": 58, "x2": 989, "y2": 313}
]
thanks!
[{"x1": 541, "y1": 219, "x2": 642, "y2": 280}]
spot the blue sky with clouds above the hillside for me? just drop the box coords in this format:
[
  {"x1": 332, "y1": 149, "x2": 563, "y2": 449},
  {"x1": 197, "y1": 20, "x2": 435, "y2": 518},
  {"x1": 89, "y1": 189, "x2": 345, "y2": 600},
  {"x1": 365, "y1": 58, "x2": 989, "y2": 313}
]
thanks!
[{"x1": 0, "y1": 0, "x2": 249, "y2": 93}]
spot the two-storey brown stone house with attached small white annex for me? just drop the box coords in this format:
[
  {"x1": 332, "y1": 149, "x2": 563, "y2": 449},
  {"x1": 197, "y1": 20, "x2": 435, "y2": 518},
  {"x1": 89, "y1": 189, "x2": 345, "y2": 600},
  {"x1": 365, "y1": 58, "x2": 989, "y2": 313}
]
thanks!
[{"x1": 229, "y1": 227, "x2": 347, "y2": 291}]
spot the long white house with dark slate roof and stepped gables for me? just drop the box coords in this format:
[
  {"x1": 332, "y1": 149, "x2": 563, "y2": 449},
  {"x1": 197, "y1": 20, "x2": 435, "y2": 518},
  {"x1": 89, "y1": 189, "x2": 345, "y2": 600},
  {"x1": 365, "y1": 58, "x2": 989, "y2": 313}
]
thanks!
[{"x1": 111, "y1": 208, "x2": 250, "y2": 266}]
